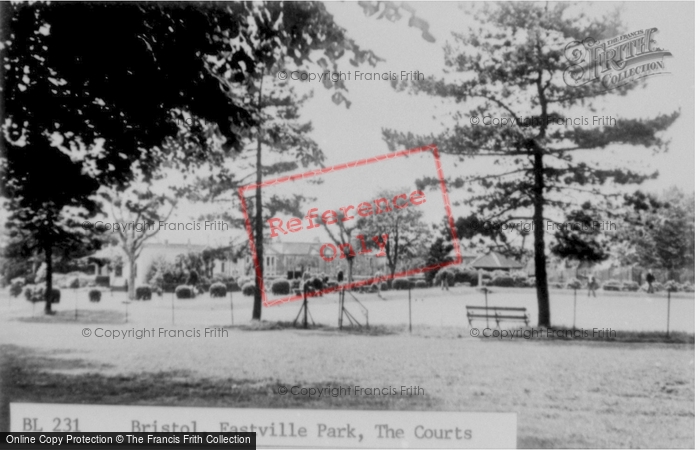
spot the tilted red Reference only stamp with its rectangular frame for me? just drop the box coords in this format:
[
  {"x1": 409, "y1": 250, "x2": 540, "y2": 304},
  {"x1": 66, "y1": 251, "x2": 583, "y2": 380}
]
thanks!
[{"x1": 238, "y1": 145, "x2": 462, "y2": 306}]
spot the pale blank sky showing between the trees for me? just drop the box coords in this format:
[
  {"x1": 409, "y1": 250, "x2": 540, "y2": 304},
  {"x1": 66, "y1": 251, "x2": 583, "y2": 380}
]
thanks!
[{"x1": 0, "y1": 1, "x2": 695, "y2": 245}]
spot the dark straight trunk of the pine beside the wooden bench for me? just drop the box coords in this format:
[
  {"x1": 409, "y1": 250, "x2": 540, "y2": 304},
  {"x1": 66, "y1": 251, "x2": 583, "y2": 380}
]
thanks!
[{"x1": 533, "y1": 148, "x2": 551, "y2": 327}]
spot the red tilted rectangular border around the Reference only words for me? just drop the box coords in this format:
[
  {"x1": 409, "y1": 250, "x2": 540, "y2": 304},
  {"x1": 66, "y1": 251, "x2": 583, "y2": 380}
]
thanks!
[{"x1": 238, "y1": 144, "x2": 462, "y2": 307}]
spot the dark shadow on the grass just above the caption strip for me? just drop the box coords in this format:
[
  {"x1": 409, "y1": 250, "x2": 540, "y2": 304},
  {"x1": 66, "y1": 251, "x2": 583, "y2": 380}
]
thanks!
[{"x1": 0, "y1": 346, "x2": 441, "y2": 420}]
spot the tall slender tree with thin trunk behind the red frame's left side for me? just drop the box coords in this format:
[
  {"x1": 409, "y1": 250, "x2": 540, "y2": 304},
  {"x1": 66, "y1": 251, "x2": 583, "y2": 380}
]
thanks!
[{"x1": 186, "y1": 2, "x2": 379, "y2": 320}]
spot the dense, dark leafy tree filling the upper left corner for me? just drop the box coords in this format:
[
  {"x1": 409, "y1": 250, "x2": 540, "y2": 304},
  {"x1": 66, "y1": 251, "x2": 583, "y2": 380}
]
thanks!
[{"x1": 0, "y1": 3, "x2": 254, "y2": 312}]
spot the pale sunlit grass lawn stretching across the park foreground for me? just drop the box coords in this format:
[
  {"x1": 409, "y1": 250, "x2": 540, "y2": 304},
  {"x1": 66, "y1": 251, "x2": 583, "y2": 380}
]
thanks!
[{"x1": 0, "y1": 290, "x2": 695, "y2": 447}]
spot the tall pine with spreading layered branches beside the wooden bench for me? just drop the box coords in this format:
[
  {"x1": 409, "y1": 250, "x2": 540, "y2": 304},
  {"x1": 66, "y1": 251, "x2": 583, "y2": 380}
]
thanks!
[{"x1": 384, "y1": 3, "x2": 678, "y2": 326}]
